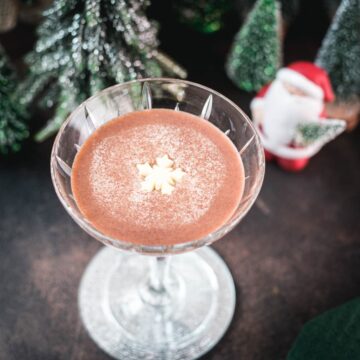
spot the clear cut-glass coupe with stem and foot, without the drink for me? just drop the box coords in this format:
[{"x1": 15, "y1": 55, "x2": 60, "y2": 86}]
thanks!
[{"x1": 51, "y1": 78, "x2": 265, "y2": 360}]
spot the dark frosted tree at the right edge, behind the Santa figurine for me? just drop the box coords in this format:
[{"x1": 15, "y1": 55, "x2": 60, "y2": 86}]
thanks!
[{"x1": 316, "y1": 0, "x2": 360, "y2": 101}]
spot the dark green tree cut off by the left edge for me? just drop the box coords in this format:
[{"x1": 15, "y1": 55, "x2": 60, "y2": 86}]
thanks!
[{"x1": 0, "y1": 47, "x2": 29, "y2": 154}]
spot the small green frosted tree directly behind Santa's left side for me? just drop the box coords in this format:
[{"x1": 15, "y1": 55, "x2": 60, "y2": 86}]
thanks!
[{"x1": 225, "y1": 0, "x2": 281, "y2": 91}]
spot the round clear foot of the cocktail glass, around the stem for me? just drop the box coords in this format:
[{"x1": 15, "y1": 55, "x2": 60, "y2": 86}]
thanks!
[{"x1": 79, "y1": 247, "x2": 235, "y2": 360}]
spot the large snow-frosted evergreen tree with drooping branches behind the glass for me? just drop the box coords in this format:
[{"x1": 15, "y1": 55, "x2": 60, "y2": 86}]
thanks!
[{"x1": 20, "y1": 0, "x2": 186, "y2": 141}]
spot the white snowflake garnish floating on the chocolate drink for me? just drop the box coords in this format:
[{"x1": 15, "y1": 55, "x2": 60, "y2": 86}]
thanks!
[{"x1": 136, "y1": 155, "x2": 185, "y2": 195}]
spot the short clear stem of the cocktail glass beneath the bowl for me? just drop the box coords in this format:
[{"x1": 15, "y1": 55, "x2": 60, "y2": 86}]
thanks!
[{"x1": 142, "y1": 256, "x2": 170, "y2": 306}]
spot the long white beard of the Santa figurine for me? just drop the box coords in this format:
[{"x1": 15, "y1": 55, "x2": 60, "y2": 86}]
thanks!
[{"x1": 263, "y1": 79, "x2": 324, "y2": 145}]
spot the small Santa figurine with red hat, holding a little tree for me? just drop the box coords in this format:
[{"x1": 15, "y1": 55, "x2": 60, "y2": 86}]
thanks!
[{"x1": 251, "y1": 61, "x2": 345, "y2": 171}]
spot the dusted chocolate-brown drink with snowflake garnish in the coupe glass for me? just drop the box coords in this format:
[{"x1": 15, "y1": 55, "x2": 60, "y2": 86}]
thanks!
[{"x1": 71, "y1": 109, "x2": 244, "y2": 245}]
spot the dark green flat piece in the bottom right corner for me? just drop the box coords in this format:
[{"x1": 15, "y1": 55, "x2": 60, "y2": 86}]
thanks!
[{"x1": 287, "y1": 298, "x2": 360, "y2": 360}]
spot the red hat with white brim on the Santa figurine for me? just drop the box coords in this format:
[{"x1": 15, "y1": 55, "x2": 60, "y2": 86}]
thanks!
[{"x1": 276, "y1": 61, "x2": 335, "y2": 102}]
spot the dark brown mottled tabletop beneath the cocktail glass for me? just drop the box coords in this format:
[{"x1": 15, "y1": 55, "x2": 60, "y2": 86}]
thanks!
[{"x1": 0, "y1": 4, "x2": 360, "y2": 360}]
